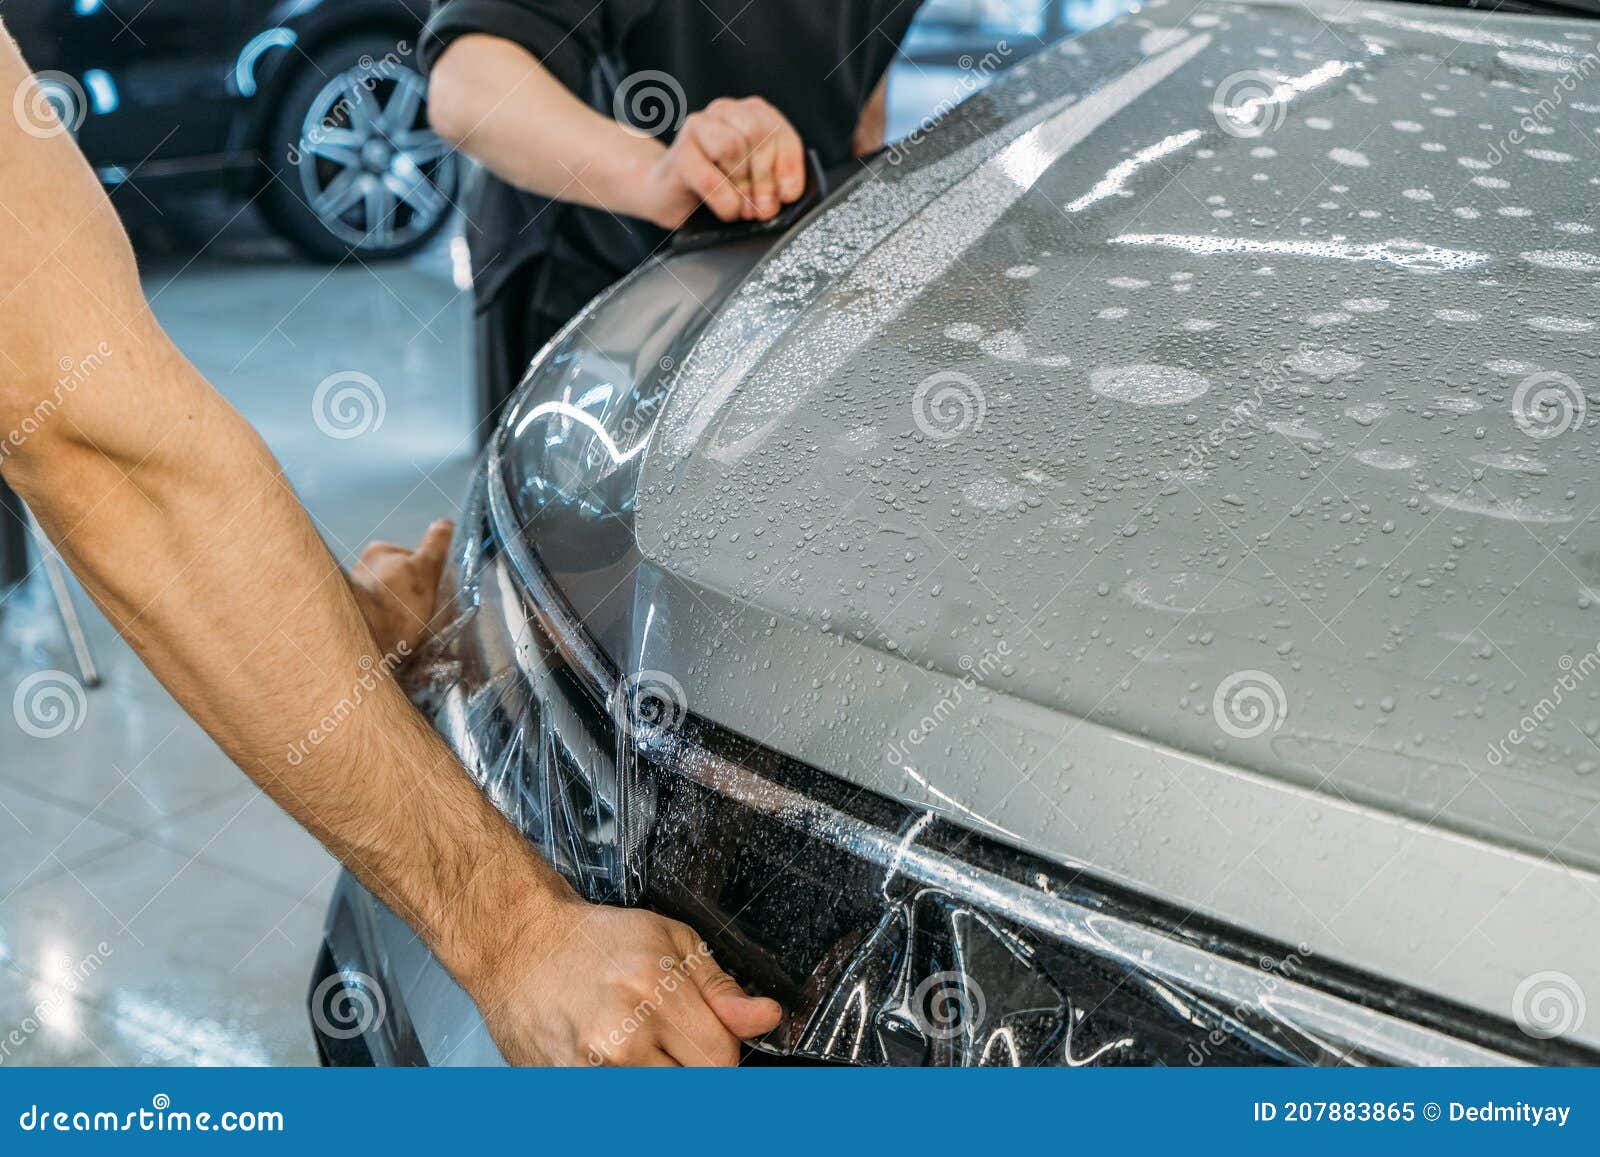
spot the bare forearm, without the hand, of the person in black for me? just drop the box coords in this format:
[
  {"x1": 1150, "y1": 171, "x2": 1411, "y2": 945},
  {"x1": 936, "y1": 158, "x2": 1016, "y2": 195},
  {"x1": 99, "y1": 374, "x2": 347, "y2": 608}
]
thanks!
[{"x1": 429, "y1": 35, "x2": 662, "y2": 216}]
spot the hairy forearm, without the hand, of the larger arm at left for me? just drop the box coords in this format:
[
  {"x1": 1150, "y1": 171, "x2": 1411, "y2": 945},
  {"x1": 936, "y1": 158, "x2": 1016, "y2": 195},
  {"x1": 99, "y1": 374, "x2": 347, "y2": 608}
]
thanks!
[{"x1": 6, "y1": 350, "x2": 565, "y2": 976}]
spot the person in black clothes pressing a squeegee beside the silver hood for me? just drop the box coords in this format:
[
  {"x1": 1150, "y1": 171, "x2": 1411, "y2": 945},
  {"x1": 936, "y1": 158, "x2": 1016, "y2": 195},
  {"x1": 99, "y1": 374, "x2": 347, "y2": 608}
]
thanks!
[{"x1": 422, "y1": 0, "x2": 920, "y2": 437}]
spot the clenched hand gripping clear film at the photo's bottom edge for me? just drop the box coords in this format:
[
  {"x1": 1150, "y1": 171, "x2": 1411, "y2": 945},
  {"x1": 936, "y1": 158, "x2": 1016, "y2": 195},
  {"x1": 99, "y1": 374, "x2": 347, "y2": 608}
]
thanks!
[{"x1": 467, "y1": 896, "x2": 782, "y2": 1066}]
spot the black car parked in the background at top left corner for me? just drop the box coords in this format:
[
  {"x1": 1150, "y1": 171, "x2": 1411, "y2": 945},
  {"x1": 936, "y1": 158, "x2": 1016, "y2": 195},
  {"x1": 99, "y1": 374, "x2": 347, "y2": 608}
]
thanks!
[{"x1": 0, "y1": 0, "x2": 458, "y2": 261}]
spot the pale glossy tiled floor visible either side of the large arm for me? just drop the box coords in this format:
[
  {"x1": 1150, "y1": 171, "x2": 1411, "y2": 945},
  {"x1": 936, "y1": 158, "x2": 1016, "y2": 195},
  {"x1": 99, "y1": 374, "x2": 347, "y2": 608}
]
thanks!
[{"x1": 0, "y1": 205, "x2": 474, "y2": 1064}]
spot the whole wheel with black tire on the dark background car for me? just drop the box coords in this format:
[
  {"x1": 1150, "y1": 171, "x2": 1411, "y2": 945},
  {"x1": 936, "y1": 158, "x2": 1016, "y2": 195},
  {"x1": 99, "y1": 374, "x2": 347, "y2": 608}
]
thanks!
[{"x1": 261, "y1": 35, "x2": 461, "y2": 261}]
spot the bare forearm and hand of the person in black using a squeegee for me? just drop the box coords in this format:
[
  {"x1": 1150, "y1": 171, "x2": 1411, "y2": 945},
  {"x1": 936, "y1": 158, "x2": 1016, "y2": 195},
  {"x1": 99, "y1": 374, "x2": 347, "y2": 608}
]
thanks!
[{"x1": 427, "y1": 35, "x2": 805, "y2": 229}]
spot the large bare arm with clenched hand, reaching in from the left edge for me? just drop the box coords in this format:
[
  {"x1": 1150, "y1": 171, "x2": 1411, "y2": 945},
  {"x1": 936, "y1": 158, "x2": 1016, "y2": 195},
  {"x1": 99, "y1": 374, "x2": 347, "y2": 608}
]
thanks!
[{"x1": 0, "y1": 35, "x2": 779, "y2": 1063}]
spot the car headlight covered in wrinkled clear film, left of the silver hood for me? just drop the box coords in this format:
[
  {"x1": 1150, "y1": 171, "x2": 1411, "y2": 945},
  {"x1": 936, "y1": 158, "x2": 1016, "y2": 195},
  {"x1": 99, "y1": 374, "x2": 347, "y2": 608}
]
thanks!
[{"x1": 406, "y1": 253, "x2": 732, "y2": 903}]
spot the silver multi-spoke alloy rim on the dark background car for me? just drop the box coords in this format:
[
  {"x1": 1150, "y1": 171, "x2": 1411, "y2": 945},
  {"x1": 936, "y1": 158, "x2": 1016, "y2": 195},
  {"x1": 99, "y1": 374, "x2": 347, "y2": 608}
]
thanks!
[{"x1": 296, "y1": 58, "x2": 456, "y2": 250}]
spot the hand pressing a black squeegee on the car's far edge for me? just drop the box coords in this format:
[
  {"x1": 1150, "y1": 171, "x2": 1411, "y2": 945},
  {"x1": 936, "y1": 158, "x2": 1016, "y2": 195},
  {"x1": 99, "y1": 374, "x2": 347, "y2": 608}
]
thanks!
[{"x1": 635, "y1": 96, "x2": 805, "y2": 229}]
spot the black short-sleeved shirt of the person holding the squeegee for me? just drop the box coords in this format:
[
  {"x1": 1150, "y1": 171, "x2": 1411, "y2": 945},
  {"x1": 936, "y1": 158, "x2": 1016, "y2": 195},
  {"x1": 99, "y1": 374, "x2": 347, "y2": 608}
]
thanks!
[{"x1": 422, "y1": 0, "x2": 922, "y2": 320}]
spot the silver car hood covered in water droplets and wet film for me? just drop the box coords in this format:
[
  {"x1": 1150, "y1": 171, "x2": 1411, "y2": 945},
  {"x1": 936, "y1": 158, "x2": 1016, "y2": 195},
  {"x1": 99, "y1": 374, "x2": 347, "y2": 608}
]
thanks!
[{"x1": 635, "y1": 3, "x2": 1600, "y2": 1043}]
